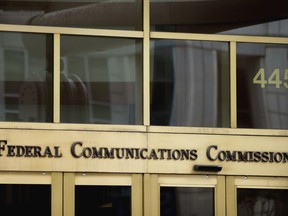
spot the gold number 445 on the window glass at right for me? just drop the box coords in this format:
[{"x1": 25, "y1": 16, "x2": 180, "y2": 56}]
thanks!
[{"x1": 253, "y1": 68, "x2": 288, "y2": 88}]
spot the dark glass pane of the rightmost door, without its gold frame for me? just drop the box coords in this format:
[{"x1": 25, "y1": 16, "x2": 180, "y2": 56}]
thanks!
[{"x1": 237, "y1": 189, "x2": 288, "y2": 216}]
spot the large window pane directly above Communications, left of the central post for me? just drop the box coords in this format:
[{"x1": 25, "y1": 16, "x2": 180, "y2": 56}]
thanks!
[{"x1": 61, "y1": 36, "x2": 142, "y2": 125}]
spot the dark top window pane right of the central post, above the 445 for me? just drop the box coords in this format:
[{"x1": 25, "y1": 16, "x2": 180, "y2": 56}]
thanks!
[{"x1": 150, "y1": 0, "x2": 288, "y2": 36}]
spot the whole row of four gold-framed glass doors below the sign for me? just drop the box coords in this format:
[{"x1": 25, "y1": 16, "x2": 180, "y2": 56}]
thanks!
[{"x1": 0, "y1": 172, "x2": 288, "y2": 216}]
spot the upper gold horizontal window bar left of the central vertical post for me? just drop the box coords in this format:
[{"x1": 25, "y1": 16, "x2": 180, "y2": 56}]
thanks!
[{"x1": 0, "y1": 24, "x2": 144, "y2": 38}]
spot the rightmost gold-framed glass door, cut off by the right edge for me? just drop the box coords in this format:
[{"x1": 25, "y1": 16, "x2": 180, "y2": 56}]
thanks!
[{"x1": 227, "y1": 176, "x2": 288, "y2": 216}]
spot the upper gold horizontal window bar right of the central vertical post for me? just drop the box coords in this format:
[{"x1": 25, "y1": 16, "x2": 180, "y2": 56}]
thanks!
[{"x1": 150, "y1": 32, "x2": 288, "y2": 44}]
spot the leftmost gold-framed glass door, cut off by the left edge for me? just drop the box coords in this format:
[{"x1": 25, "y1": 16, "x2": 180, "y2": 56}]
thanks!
[{"x1": 0, "y1": 172, "x2": 62, "y2": 216}]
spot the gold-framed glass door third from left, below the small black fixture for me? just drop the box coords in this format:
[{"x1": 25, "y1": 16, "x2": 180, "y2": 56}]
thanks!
[{"x1": 144, "y1": 175, "x2": 225, "y2": 216}]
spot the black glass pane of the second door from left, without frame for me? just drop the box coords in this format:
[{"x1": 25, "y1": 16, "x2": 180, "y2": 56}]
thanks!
[{"x1": 75, "y1": 186, "x2": 131, "y2": 216}]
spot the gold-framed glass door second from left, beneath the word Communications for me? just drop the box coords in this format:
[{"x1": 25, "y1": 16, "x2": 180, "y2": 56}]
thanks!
[{"x1": 64, "y1": 173, "x2": 142, "y2": 216}]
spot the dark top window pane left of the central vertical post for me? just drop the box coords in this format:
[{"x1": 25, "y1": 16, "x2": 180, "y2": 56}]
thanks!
[{"x1": 0, "y1": 0, "x2": 142, "y2": 30}]
